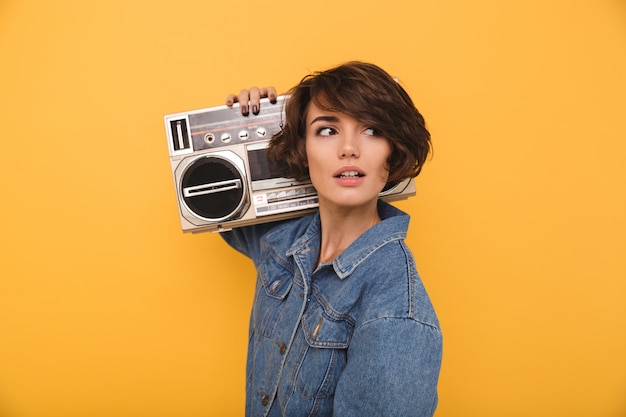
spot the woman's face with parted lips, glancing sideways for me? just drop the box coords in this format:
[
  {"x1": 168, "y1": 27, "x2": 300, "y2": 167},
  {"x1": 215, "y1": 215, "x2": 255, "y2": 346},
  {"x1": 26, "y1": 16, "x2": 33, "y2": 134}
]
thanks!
[{"x1": 306, "y1": 102, "x2": 391, "y2": 208}]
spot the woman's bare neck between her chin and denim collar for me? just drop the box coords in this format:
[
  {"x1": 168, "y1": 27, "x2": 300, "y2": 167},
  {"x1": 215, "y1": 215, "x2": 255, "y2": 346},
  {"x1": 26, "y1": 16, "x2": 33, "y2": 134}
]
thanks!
[{"x1": 318, "y1": 201, "x2": 380, "y2": 263}]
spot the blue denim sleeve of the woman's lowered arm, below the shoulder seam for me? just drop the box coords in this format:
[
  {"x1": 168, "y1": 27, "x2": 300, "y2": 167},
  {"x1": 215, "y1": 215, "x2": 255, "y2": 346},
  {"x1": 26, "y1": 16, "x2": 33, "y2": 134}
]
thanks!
[{"x1": 334, "y1": 318, "x2": 442, "y2": 417}]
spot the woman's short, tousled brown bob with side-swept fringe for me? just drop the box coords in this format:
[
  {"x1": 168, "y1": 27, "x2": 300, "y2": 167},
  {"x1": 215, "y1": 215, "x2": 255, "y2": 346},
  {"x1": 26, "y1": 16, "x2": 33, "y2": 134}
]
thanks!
[{"x1": 268, "y1": 61, "x2": 431, "y2": 182}]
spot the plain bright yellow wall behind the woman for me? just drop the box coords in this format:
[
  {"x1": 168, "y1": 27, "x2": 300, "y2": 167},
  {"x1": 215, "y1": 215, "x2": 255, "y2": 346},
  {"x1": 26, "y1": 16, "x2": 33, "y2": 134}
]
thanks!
[{"x1": 0, "y1": 0, "x2": 626, "y2": 417}]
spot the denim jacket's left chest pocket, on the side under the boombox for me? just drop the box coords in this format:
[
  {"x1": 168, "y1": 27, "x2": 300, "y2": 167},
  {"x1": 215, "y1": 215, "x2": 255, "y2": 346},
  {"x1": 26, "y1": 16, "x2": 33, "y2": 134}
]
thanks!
[{"x1": 252, "y1": 256, "x2": 293, "y2": 337}]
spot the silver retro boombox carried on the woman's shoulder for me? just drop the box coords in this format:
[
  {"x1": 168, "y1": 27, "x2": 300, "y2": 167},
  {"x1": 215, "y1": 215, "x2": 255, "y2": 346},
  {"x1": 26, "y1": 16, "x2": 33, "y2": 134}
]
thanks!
[{"x1": 165, "y1": 96, "x2": 415, "y2": 233}]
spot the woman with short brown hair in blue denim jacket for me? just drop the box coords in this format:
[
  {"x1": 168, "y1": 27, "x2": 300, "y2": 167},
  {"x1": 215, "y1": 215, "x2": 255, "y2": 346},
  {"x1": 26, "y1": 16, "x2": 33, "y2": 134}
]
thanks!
[{"x1": 222, "y1": 62, "x2": 442, "y2": 417}]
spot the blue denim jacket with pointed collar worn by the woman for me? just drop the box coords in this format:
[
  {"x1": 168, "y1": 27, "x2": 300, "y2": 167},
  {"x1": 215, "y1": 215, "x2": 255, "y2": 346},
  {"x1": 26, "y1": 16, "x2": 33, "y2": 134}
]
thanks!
[{"x1": 222, "y1": 202, "x2": 442, "y2": 417}]
